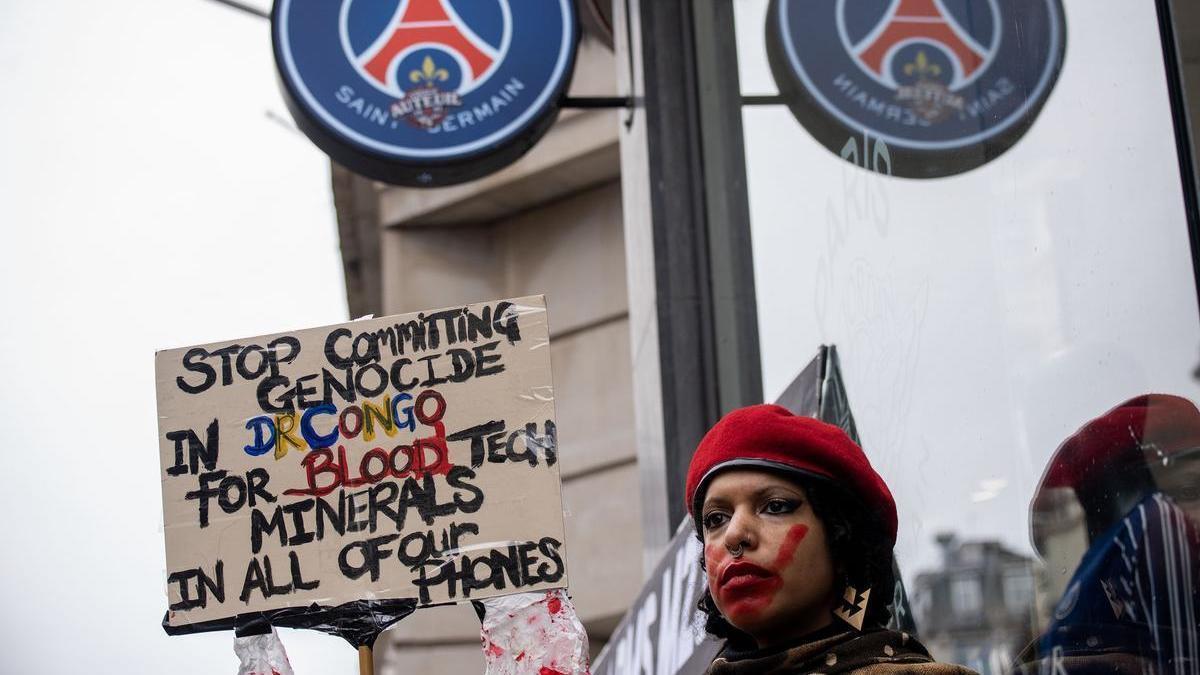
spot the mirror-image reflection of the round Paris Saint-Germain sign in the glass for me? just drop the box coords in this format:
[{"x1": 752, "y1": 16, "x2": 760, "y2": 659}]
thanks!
[{"x1": 767, "y1": 0, "x2": 1066, "y2": 178}]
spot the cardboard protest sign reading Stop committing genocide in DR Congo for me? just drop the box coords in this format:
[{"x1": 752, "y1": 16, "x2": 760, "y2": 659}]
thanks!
[{"x1": 155, "y1": 297, "x2": 566, "y2": 627}]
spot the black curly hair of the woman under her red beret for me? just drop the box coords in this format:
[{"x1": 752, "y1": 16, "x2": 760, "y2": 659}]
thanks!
[{"x1": 694, "y1": 472, "x2": 895, "y2": 649}]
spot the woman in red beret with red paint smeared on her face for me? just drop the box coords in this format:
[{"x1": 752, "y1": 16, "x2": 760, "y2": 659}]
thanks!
[{"x1": 686, "y1": 405, "x2": 971, "y2": 675}]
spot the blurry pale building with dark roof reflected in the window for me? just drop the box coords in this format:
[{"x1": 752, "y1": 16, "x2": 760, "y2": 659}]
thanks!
[{"x1": 912, "y1": 534, "x2": 1036, "y2": 675}]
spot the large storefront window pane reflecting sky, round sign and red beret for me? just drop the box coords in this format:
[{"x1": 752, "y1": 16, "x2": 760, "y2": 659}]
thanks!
[{"x1": 736, "y1": 0, "x2": 1200, "y2": 673}]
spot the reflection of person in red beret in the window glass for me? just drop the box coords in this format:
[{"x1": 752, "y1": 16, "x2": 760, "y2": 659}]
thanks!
[{"x1": 1020, "y1": 394, "x2": 1200, "y2": 673}]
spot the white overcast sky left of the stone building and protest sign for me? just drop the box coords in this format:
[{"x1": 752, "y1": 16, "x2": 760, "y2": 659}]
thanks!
[{"x1": 0, "y1": 0, "x2": 358, "y2": 675}]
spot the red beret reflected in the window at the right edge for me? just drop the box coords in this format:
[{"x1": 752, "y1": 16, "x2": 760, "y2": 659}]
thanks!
[{"x1": 1037, "y1": 394, "x2": 1200, "y2": 494}]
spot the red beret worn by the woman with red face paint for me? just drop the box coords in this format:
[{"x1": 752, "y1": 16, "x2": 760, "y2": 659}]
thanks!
[{"x1": 684, "y1": 405, "x2": 896, "y2": 544}]
